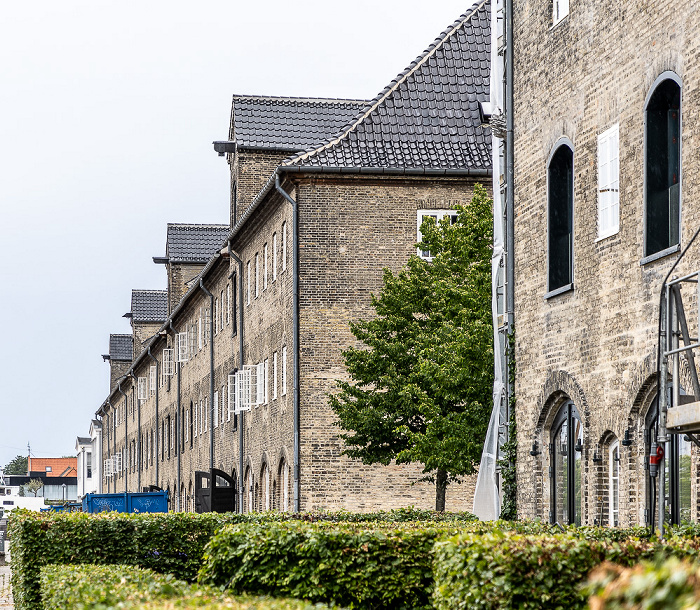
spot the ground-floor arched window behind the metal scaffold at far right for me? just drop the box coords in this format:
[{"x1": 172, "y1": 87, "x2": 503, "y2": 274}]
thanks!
[{"x1": 644, "y1": 388, "x2": 691, "y2": 524}]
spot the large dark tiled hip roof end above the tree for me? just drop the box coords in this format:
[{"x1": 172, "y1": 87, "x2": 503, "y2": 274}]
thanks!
[{"x1": 283, "y1": 0, "x2": 491, "y2": 170}]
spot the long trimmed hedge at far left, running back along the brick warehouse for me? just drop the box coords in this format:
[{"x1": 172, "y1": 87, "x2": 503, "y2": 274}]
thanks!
[{"x1": 9, "y1": 508, "x2": 475, "y2": 610}]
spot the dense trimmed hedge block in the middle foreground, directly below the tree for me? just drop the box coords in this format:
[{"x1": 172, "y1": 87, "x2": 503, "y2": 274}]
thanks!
[{"x1": 199, "y1": 523, "x2": 458, "y2": 608}]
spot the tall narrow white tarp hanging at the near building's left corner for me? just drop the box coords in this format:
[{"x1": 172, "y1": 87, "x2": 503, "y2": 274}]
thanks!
[{"x1": 473, "y1": 0, "x2": 506, "y2": 521}]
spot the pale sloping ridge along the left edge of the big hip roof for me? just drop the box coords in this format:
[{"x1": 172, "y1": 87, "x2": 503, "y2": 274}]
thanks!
[{"x1": 281, "y1": 0, "x2": 490, "y2": 167}]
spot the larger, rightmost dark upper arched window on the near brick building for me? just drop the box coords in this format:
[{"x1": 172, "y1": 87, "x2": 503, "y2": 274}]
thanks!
[{"x1": 644, "y1": 73, "x2": 681, "y2": 256}]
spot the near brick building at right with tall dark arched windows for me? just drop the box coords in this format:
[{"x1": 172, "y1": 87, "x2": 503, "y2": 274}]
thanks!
[{"x1": 513, "y1": 0, "x2": 700, "y2": 526}]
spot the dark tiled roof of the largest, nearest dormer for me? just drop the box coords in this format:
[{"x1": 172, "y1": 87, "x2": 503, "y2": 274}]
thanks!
[{"x1": 231, "y1": 95, "x2": 369, "y2": 152}]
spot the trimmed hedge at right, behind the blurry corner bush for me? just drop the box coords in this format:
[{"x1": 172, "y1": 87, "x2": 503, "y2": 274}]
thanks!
[{"x1": 433, "y1": 528, "x2": 700, "y2": 610}]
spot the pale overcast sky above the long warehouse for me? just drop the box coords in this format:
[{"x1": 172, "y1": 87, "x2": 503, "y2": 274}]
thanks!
[{"x1": 0, "y1": 0, "x2": 471, "y2": 465}]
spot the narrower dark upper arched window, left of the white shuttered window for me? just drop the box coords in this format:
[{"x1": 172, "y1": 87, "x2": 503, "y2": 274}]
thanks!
[{"x1": 547, "y1": 144, "x2": 574, "y2": 292}]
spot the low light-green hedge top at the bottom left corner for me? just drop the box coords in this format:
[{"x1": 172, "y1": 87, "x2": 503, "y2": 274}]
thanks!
[{"x1": 40, "y1": 565, "x2": 334, "y2": 610}]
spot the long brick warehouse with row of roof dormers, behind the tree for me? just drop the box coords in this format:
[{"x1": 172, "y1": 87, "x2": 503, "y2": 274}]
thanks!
[{"x1": 91, "y1": 2, "x2": 491, "y2": 511}]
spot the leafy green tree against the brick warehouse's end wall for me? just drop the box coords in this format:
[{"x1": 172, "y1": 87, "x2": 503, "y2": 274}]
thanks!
[{"x1": 330, "y1": 186, "x2": 493, "y2": 510}]
